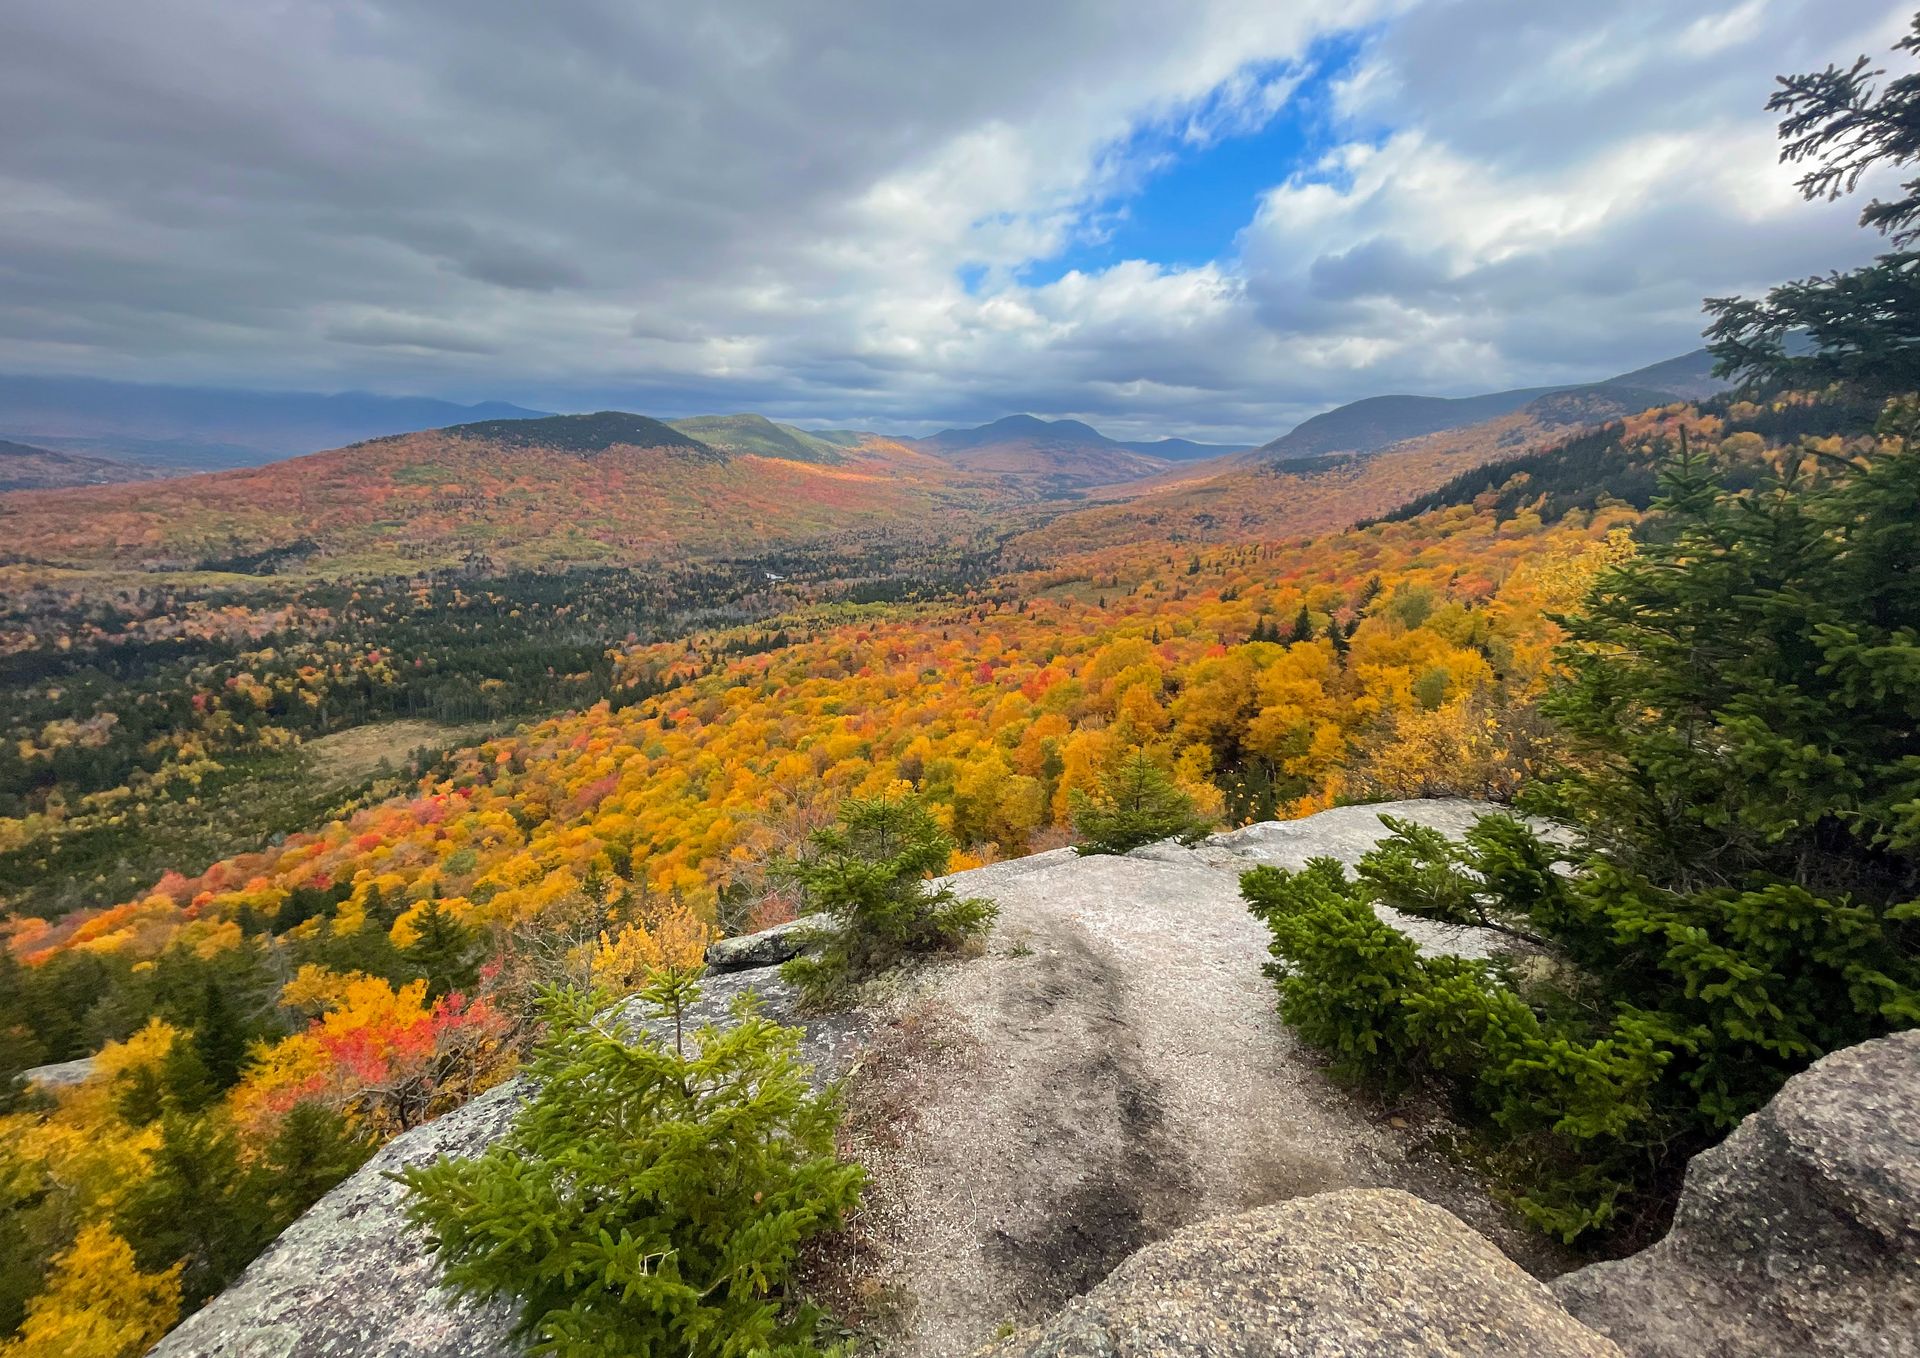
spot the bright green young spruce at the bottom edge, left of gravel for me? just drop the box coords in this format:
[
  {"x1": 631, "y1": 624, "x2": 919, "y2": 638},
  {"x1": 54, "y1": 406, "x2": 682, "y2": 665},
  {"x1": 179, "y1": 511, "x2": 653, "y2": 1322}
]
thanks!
[{"x1": 396, "y1": 972, "x2": 862, "y2": 1358}]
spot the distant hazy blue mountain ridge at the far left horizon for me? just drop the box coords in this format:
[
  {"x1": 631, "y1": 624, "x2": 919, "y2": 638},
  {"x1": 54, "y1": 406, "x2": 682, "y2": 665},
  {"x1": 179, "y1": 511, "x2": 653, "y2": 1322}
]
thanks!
[{"x1": 0, "y1": 375, "x2": 545, "y2": 471}]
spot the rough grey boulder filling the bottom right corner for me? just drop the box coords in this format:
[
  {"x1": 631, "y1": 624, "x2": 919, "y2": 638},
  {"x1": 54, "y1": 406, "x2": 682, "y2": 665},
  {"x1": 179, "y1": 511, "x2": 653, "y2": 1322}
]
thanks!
[{"x1": 1553, "y1": 1031, "x2": 1920, "y2": 1358}]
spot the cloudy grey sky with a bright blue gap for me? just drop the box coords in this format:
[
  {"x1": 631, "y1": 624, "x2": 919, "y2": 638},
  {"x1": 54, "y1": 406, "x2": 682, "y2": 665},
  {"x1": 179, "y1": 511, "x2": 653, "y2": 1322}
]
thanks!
[{"x1": 0, "y1": 0, "x2": 1912, "y2": 442}]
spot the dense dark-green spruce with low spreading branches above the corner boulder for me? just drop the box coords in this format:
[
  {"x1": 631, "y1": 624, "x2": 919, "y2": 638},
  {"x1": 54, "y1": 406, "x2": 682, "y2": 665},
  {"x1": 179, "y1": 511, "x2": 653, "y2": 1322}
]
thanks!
[{"x1": 1242, "y1": 424, "x2": 1920, "y2": 1239}]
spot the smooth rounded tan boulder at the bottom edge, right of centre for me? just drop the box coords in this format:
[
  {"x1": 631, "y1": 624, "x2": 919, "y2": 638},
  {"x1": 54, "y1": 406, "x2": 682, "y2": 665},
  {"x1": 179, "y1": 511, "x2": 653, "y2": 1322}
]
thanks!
[{"x1": 983, "y1": 1189, "x2": 1620, "y2": 1358}]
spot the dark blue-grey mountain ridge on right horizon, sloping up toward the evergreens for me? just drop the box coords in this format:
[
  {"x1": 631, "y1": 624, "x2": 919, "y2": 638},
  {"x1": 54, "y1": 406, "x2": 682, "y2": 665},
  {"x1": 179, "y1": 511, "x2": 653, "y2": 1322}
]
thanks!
[{"x1": 1250, "y1": 350, "x2": 1726, "y2": 463}]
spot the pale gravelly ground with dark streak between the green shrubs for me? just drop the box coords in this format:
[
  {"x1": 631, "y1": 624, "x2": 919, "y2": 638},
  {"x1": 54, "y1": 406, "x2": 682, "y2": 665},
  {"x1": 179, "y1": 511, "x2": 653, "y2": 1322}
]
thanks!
[{"x1": 822, "y1": 803, "x2": 1551, "y2": 1358}]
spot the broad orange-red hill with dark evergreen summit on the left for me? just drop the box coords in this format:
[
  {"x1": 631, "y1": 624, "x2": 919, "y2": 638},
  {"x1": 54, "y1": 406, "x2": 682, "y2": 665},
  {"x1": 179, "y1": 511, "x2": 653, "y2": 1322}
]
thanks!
[{"x1": 0, "y1": 411, "x2": 975, "y2": 576}]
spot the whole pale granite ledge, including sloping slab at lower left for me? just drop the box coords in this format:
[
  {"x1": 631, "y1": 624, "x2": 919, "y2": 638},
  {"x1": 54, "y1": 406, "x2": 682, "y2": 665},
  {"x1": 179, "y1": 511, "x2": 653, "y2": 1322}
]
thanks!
[{"x1": 145, "y1": 801, "x2": 1578, "y2": 1358}]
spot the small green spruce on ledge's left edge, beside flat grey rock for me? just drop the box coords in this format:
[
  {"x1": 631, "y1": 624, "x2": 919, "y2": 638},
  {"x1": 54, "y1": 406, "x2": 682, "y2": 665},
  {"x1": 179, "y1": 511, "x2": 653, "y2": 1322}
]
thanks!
[{"x1": 780, "y1": 797, "x2": 998, "y2": 1005}]
